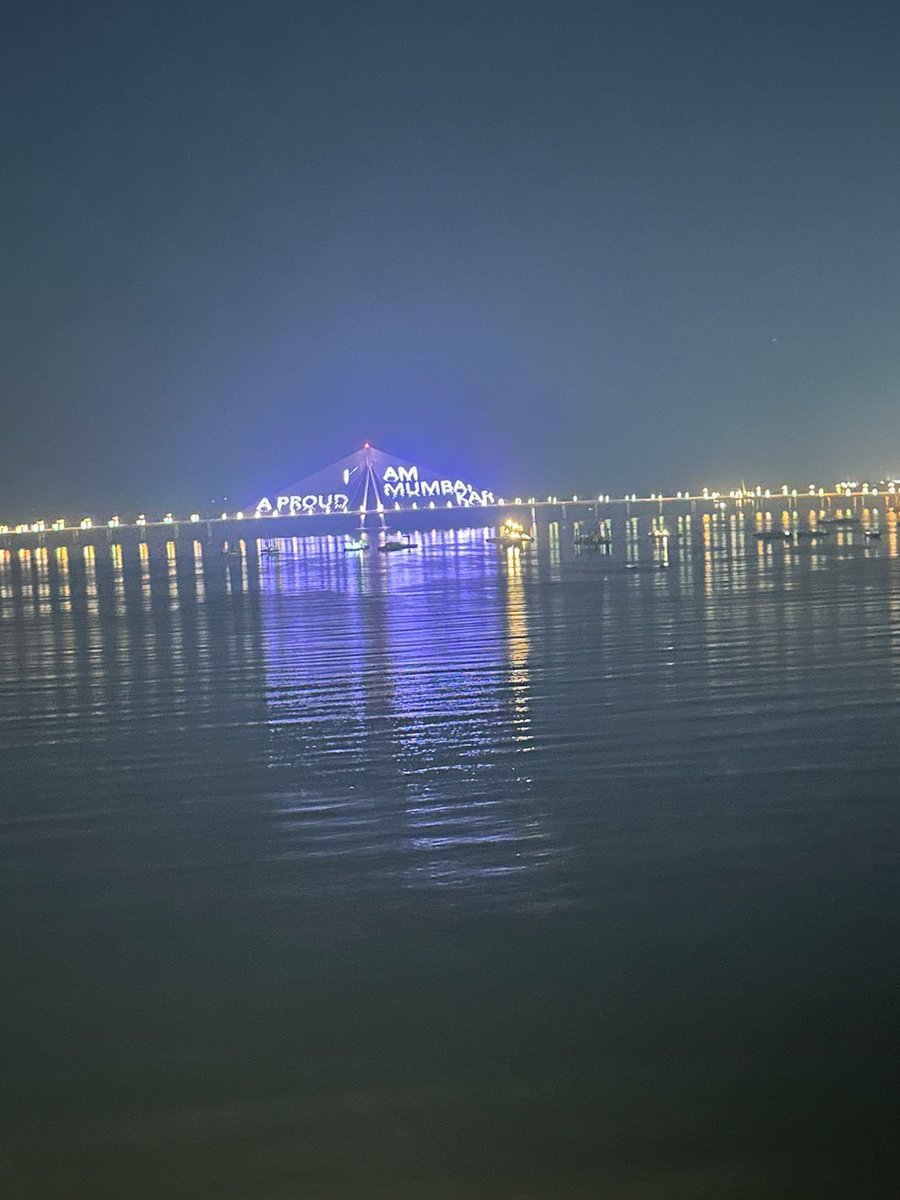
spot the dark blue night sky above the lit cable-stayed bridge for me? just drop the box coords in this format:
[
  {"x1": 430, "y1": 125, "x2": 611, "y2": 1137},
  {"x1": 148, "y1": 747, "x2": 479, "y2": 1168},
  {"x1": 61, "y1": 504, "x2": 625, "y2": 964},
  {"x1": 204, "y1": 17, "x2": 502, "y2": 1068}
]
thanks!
[{"x1": 0, "y1": 0, "x2": 900, "y2": 520}]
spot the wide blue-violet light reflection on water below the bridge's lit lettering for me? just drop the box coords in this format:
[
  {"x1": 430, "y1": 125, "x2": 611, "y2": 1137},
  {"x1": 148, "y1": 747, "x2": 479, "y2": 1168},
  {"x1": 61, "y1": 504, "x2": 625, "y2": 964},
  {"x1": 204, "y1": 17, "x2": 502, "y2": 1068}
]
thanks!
[{"x1": 260, "y1": 532, "x2": 559, "y2": 904}]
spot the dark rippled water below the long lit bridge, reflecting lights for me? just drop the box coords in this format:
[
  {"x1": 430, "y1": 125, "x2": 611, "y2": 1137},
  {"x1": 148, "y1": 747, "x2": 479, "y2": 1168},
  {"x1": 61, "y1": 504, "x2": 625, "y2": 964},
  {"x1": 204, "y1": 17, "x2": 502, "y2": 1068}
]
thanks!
[{"x1": 0, "y1": 524, "x2": 900, "y2": 1200}]
